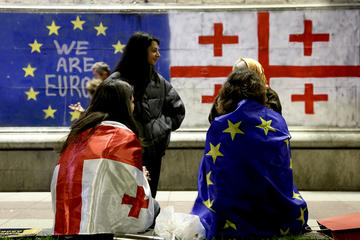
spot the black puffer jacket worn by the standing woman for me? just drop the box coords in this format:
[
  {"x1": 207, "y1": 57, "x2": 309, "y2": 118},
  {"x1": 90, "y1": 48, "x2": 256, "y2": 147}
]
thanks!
[{"x1": 109, "y1": 72, "x2": 185, "y2": 166}]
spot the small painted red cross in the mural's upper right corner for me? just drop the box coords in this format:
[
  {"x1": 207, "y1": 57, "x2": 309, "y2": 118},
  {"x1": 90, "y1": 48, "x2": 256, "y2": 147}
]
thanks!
[{"x1": 289, "y1": 20, "x2": 330, "y2": 56}]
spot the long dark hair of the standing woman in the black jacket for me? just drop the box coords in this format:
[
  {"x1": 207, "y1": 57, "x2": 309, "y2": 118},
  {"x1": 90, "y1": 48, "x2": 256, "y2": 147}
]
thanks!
[{"x1": 113, "y1": 32, "x2": 160, "y2": 98}]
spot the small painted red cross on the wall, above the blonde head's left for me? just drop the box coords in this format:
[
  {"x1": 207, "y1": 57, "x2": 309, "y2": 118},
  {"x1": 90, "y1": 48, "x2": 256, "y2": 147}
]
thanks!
[{"x1": 199, "y1": 23, "x2": 239, "y2": 57}]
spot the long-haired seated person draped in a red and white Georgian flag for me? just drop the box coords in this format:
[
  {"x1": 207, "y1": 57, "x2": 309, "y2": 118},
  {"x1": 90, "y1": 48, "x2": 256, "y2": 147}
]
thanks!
[{"x1": 51, "y1": 80, "x2": 159, "y2": 235}]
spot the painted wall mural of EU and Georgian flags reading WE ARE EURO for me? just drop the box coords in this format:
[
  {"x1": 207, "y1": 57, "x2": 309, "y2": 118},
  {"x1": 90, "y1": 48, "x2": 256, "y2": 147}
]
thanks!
[{"x1": 0, "y1": 9, "x2": 360, "y2": 128}]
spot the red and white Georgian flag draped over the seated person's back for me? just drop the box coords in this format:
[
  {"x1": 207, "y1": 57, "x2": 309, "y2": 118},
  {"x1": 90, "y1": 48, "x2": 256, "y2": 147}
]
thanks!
[{"x1": 51, "y1": 121, "x2": 154, "y2": 235}]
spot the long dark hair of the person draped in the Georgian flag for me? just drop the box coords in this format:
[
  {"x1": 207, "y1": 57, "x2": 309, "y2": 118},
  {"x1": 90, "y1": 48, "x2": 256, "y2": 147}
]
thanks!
[{"x1": 60, "y1": 79, "x2": 137, "y2": 153}]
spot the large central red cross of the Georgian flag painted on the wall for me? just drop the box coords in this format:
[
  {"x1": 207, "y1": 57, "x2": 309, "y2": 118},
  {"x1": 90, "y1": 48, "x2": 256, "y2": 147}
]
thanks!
[{"x1": 170, "y1": 12, "x2": 360, "y2": 112}]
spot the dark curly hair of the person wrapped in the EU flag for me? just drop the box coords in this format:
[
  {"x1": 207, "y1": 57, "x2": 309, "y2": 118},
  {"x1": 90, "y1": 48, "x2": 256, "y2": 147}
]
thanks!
[{"x1": 215, "y1": 69, "x2": 266, "y2": 115}]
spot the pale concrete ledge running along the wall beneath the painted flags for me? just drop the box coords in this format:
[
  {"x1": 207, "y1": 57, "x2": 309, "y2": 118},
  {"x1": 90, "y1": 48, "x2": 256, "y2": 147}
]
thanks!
[{"x1": 0, "y1": 127, "x2": 360, "y2": 149}]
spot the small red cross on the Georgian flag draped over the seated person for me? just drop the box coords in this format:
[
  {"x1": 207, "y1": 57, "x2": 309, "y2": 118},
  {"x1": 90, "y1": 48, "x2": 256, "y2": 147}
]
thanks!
[{"x1": 121, "y1": 186, "x2": 149, "y2": 218}]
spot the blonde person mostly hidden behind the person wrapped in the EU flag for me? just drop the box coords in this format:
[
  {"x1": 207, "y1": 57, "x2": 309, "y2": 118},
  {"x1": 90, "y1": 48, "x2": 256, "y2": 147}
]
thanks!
[{"x1": 208, "y1": 58, "x2": 282, "y2": 123}]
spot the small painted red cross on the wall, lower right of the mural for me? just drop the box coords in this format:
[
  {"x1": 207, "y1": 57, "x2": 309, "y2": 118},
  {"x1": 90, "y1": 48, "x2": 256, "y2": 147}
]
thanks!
[{"x1": 291, "y1": 83, "x2": 328, "y2": 114}]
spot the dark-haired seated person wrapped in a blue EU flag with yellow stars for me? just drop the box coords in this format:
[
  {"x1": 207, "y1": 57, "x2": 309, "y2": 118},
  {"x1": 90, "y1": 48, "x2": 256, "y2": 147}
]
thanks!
[{"x1": 191, "y1": 70, "x2": 308, "y2": 239}]
